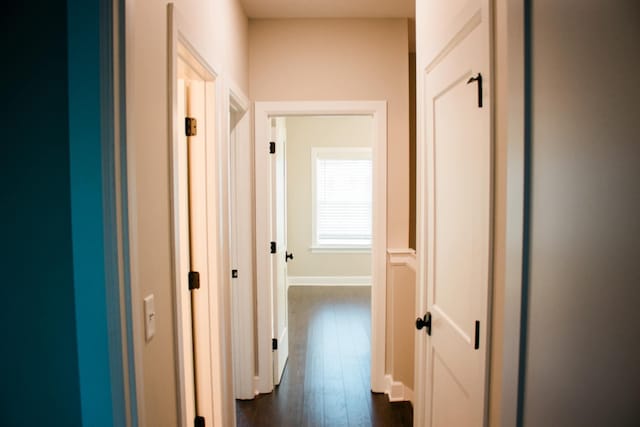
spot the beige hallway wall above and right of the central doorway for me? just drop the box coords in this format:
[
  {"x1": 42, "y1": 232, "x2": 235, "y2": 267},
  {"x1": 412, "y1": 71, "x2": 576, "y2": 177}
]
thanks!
[{"x1": 249, "y1": 19, "x2": 409, "y2": 248}]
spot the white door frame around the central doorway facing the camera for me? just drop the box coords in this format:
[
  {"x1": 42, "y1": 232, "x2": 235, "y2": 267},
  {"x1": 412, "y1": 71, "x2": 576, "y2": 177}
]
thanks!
[{"x1": 254, "y1": 101, "x2": 387, "y2": 393}]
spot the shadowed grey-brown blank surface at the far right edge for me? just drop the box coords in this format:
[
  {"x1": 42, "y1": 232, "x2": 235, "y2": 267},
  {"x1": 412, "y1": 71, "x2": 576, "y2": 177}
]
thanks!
[{"x1": 523, "y1": 0, "x2": 640, "y2": 427}]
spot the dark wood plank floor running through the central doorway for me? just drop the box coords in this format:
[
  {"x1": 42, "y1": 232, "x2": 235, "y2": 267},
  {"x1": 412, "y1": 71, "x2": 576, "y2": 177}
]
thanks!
[{"x1": 236, "y1": 287, "x2": 413, "y2": 427}]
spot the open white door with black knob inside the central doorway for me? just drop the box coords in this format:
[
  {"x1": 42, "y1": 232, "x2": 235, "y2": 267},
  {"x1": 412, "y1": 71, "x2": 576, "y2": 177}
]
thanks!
[{"x1": 271, "y1": 117, "x2": 289, "y2": 385}]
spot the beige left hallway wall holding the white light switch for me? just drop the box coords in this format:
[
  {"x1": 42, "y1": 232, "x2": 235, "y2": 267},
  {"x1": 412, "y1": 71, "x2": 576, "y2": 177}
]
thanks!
[{"x1": 126, "y1": 0, "x2": 248, "y2": 427}]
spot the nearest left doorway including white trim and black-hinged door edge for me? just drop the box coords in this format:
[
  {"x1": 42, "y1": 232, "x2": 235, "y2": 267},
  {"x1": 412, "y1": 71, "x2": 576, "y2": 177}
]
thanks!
[{"x1": 167, "y1": 4, "x2": 222, "y2": 425}]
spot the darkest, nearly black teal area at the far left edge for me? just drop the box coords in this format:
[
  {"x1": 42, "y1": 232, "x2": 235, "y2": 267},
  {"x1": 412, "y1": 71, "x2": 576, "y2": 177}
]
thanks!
[{"x1": 0, "y1": 0, "x2": 81, "y2": 426}]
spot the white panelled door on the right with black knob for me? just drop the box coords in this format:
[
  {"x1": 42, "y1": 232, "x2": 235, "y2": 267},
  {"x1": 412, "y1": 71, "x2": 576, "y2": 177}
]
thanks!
[{"x1": 417, "y1": 0, "x2": 491, "y2": 427}]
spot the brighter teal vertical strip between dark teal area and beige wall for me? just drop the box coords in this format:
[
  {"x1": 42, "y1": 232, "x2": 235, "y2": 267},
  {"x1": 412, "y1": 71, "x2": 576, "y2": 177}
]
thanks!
[{"x1": 67, "y1": 0, "x2": 125, "y2": 427}]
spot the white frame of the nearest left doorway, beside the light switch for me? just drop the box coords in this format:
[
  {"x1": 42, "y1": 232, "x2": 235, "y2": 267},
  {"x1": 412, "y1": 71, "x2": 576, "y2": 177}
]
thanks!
[{"x1": 167, "y1": 3, "x2": 235, "y2": 425}]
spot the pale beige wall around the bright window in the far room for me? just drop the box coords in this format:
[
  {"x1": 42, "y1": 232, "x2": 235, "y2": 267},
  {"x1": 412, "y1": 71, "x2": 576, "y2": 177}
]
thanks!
[{"x1": 286, "y1": 116, "x2": 373, "y2": 276}]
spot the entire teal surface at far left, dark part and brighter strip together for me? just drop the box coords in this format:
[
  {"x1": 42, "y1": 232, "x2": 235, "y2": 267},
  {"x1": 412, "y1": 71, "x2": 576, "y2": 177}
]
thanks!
[{"x1": 0, "y1": 0, "x2": 124, "y2": 427}]
